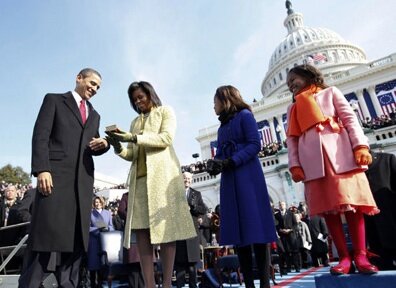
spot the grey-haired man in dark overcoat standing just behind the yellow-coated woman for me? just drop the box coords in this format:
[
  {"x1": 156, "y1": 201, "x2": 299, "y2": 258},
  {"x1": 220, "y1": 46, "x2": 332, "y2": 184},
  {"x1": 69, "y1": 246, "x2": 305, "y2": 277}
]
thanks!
[{"x1": 175, "y1": 172, "x2": 208, "y2": 288}]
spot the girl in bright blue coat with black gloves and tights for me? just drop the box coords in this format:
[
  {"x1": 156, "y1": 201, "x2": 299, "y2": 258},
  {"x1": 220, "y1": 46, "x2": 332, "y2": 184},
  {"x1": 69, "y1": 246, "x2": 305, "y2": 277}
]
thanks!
[{"x1": 207, "y1": 85, "x2": 276, "y2": 287}]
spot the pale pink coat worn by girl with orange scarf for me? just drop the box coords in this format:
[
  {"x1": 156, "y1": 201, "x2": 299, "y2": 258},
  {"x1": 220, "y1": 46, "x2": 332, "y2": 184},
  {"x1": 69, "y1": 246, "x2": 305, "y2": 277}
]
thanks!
[{"x1": 286, "y1": 87, "x2": 369, "y2": 182}]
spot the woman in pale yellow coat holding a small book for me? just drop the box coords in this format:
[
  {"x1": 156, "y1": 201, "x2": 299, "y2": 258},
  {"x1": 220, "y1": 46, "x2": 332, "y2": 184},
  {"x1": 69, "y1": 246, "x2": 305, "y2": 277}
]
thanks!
[{"x1": 107, "y1": 81, "x2": 196, "y2": 287}]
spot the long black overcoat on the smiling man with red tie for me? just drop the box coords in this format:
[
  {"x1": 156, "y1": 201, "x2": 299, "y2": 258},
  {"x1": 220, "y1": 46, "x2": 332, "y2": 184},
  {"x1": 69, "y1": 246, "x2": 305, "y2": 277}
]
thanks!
[{"x1": 29, "y1": 92, "x2": 109, "y2": 252}]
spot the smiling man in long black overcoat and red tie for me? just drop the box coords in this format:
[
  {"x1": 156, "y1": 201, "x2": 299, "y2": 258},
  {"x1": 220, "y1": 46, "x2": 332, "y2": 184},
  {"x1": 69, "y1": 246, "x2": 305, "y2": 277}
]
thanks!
[{"x1": 19, "y1": 68, "x2": 109, "y2": 288}]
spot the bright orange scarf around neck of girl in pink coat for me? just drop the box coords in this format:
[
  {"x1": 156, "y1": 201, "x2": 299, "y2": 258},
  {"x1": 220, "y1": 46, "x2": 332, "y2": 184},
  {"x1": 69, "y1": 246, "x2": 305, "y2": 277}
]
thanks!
[{"x1": 287, "y1": 85, "x2": 326, "y2": 136}]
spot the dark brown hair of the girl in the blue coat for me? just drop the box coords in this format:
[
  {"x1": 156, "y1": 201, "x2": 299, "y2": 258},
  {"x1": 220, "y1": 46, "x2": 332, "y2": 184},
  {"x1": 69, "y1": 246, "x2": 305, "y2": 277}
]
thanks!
[{"x1": 215, "y1": 85, "x2": 252, "y2": 113}]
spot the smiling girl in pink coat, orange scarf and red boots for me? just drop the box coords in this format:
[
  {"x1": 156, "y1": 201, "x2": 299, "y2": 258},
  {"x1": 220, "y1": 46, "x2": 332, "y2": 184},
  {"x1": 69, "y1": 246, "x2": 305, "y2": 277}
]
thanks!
[{"x1": 286, "y1": 65, "x2": 379, "y2": 275}]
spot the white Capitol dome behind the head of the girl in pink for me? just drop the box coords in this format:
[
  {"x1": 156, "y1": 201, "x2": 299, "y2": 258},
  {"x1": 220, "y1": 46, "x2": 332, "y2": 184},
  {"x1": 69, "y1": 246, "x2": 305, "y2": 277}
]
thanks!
[{"x1": 261, "y1": 1, "x2": 367, "y2": 98}]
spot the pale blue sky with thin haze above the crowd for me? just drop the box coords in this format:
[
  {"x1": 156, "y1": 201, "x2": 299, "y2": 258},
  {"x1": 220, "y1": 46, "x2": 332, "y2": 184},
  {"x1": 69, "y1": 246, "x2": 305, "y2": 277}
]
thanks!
[{"x1": 0, "y1": 0, "x2": 396, "y2": 183}]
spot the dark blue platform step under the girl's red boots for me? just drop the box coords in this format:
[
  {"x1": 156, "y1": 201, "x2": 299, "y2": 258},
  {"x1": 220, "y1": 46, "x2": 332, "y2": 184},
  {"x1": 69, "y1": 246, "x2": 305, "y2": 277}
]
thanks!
[{"x1": 315, "y1": 271, "x2": 396, "y2": 288}]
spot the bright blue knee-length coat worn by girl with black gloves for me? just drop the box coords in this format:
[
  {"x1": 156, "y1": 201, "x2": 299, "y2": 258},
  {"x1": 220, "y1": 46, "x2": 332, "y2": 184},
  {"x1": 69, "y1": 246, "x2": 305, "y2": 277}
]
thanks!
[{"x1": 215, "y1": 109, "x2": 276, "y2": 246}]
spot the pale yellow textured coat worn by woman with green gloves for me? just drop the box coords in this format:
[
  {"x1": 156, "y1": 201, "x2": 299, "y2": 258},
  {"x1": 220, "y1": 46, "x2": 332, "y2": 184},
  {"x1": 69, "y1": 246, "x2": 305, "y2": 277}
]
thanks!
[{"x1": 118, "y1": 106, "x2": 196, "y2": 248}]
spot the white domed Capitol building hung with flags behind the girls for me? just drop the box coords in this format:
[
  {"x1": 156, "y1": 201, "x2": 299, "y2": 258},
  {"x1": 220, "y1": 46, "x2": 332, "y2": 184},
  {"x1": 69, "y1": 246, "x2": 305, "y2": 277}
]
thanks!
[{"x1": 193, "y1": 1, "x2": 396, "y2": 207}]
